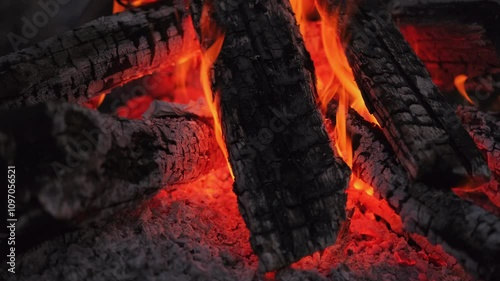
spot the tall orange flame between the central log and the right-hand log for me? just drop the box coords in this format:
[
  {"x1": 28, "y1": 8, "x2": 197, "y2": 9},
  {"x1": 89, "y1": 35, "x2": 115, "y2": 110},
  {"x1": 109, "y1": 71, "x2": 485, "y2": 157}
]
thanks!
[{"x1": 290, "y1": 0, "x2": 378, "y2": 195}]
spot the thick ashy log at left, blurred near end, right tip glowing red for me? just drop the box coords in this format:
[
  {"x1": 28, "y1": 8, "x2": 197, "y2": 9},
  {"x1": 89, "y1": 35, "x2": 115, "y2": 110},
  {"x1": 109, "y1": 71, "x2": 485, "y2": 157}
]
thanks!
[{"x1": 0, "y1": 103, "x2": 226, "y2": 252}]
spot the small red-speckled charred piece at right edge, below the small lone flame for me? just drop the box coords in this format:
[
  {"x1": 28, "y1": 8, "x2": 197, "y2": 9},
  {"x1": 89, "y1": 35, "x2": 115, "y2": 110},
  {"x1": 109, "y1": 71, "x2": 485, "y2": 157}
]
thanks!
[{"x1": 457, "y1": 106, "x2": 500, "y2": 207}]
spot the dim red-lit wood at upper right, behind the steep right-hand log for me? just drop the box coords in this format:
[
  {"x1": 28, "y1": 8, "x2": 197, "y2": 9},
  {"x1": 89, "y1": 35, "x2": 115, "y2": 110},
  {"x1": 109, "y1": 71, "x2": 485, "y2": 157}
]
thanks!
[{"x1": 397, "y1": 23, "x2": 500, "y2": 94}]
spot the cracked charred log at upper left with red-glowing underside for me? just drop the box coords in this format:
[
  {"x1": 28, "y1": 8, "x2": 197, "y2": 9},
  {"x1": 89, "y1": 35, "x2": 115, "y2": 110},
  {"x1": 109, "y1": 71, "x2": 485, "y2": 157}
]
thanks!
[{"x1": 0, "y1": 0, "x2": 199, "y2": 109}]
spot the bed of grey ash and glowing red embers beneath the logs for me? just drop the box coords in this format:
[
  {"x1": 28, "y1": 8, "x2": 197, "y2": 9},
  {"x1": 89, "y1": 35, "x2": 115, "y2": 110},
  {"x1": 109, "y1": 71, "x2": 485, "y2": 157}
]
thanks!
[{"x1": 0, "y1": 169, "x2": 474, "y2": 281}]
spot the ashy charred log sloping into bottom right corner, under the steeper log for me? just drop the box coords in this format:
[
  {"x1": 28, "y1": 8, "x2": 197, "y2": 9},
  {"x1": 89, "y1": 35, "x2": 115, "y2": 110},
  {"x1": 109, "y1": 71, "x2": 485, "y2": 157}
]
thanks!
[{"x1": 327, "y1": 102, "x2": 500, "y2": 280}]
